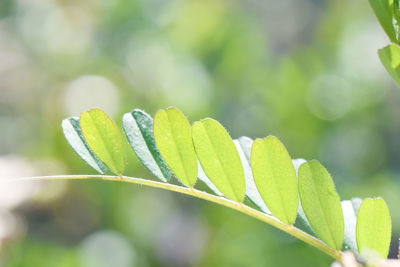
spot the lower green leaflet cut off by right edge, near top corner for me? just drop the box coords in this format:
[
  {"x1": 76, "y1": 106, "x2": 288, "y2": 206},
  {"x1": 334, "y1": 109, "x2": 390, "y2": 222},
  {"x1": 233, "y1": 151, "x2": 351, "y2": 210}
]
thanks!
[{"x1": 378, "y1": 44, "x2": 400, "y2": 86}]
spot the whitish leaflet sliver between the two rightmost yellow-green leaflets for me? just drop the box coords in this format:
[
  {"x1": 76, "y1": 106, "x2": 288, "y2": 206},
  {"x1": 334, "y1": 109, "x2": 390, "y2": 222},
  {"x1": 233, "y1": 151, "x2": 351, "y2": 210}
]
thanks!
[{"x1": 342, "y1": 198, "x2": 362, "y2": 252}]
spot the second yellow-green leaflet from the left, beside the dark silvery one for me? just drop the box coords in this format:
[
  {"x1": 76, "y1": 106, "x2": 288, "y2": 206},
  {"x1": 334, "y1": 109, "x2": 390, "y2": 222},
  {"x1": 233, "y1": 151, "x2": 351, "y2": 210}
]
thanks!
[{"x1": 153, "y1": 107, "x2": 197, "y2": 187}]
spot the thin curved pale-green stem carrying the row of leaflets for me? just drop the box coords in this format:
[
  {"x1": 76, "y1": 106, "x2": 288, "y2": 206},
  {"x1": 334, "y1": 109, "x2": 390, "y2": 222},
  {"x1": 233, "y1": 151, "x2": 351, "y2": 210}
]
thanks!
[{"x1": 12, "y1": 175, "x2": 341, "y2": 261}]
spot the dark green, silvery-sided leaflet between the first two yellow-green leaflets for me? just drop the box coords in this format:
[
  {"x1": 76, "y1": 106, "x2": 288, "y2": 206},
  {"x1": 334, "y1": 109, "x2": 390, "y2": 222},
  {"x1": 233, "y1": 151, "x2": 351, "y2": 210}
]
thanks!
[{"x1": 122, "y1": 109, "x2": 172, "y2": 182}]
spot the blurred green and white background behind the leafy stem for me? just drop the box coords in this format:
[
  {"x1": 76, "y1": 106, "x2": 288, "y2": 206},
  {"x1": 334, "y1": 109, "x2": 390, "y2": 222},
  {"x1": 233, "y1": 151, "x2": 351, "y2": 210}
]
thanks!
[{"x1": 0, "y1": 0, "x2": 400, "y2": 267}]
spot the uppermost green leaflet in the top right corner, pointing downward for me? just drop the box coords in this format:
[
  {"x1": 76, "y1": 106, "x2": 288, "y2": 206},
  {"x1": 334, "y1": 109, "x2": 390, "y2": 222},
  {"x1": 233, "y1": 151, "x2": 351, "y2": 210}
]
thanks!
[{"x1": 368, "y1": 0, "x2": 397, "y2": 43}]
